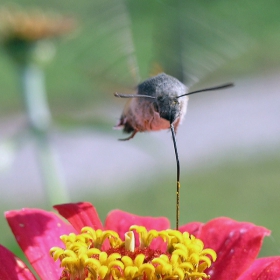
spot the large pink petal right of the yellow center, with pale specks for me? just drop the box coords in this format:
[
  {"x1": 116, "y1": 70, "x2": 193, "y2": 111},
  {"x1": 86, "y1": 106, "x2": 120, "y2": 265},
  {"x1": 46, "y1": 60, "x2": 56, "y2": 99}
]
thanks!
[{"x1": 197, "y1": 218, "x2": 270, "y2": 280}]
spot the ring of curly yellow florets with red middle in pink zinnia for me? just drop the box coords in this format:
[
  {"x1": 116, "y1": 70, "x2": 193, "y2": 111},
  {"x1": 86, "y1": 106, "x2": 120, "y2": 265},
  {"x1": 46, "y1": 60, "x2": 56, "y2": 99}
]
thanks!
[{"x1": 50, "y1": 226, "x2": 217, "y2": 280}]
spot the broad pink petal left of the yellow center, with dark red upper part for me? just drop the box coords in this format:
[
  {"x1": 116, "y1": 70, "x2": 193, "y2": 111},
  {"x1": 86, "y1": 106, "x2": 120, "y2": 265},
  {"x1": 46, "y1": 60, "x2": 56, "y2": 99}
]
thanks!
[{"x1": 5, "y1": 209, "x2": 75, "y2": 280}]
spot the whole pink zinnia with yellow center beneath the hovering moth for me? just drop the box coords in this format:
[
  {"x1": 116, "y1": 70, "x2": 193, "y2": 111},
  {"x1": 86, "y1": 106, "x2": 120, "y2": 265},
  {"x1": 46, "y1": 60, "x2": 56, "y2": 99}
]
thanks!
[{"x1": 0, "y1": 203, "x2": 280, "y2": 280}]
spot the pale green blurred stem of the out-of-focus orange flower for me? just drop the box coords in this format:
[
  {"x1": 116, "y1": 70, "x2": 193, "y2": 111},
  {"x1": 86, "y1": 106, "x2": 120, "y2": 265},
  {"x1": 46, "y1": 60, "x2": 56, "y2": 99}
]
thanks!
[{"x1": 20, "y1": 63, "x2": 69, "y2": 205}]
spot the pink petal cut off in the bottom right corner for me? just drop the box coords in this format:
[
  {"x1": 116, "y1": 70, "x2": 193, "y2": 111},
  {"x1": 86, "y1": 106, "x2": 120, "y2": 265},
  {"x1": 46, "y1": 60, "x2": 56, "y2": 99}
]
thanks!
[{"x1": 238, "y1": 257, "x2": 280, "y2": 280}]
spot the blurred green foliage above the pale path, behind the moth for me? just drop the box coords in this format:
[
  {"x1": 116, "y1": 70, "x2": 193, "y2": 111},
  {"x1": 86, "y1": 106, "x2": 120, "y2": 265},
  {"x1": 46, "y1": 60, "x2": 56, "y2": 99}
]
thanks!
[{"x1": 0, "y1": 0, "x2": 280, "y2": 121}]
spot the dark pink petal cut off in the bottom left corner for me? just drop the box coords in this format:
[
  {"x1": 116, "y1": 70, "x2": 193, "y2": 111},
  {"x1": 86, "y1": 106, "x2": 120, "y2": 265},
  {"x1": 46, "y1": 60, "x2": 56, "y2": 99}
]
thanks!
[{"x1": 0, "y1": 245, "x2": 36, "y2": 280}]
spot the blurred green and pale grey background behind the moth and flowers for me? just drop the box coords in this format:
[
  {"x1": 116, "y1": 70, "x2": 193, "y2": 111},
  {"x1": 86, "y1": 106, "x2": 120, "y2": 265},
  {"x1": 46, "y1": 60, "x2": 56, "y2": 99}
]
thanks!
[{"x1": 0, "y1": 0, "x2": 280, "y2": 264}]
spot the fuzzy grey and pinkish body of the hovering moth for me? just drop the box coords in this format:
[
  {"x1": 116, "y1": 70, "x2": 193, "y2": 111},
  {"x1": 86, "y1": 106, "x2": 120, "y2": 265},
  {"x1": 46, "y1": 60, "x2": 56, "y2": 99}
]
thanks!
[{"x1": 116, "y1": 73, "x2": 188, "y2": 140}]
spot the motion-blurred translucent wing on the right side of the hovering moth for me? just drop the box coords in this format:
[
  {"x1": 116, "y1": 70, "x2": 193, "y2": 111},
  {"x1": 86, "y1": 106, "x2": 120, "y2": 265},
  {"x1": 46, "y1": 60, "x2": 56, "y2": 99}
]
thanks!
[{"x1": 149, "y1": 1, "x2": 249, "y2": 87}]
